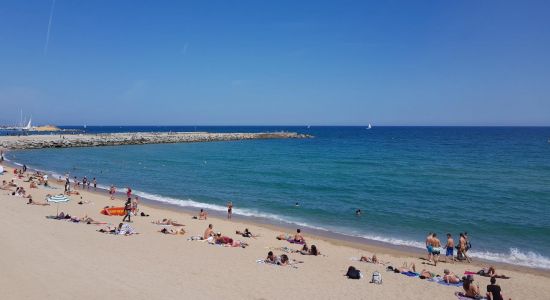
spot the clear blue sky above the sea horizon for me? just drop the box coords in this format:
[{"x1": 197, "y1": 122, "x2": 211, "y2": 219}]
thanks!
[{"x1": 0, "y1": 0, "x2": 550, "y2": 125}]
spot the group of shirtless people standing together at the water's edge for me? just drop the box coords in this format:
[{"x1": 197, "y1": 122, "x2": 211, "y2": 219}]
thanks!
[{"x1": 426, "y1": 232, "x2": 472, "y2": 266}]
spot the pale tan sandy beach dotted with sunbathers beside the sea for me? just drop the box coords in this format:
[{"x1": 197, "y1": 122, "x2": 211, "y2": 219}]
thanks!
[{"x1": 0, "y1": 167, "x2": 550, "y2": 299}]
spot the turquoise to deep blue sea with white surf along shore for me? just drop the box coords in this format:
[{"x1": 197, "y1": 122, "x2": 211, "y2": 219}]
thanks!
[{"x1": 8, "y1": 127, "x2": 550, "y2": 269}]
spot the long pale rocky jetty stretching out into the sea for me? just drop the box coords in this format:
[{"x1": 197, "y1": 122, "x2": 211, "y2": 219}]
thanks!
[{"x1": 0, "y1": 132, "x2": 312, "y2": 150}]
